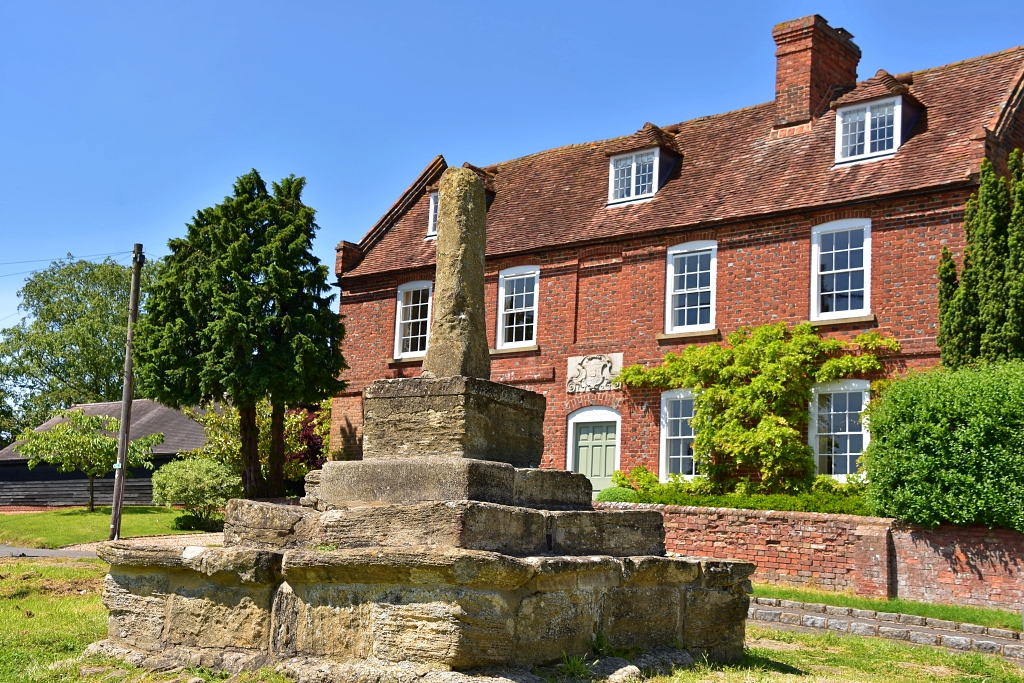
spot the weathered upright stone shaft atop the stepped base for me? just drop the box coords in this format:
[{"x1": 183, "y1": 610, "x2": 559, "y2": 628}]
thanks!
[{"x1": 423, "y1": 168, "x2": 490, "y2": 380}]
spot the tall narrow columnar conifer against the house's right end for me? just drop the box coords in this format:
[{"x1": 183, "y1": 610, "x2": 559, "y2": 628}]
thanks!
[{"x1": 937, "y1": 154, "x2": 1024, "y2": 369}]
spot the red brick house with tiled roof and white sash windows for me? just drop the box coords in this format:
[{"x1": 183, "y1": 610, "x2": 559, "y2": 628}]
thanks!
[{"x1": 333, "y1": 15, "x2": 1024, "y2": 487}]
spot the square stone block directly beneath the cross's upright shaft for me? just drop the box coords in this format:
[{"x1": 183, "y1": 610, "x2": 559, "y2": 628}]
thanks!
[{"x1": 362, "y1": 377, "x2": 546, "y2": 467}]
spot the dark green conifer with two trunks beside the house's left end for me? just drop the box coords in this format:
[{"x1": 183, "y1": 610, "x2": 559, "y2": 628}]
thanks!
[{"x1": 137, "y1": 169, "x2": 346, "y2": 498}]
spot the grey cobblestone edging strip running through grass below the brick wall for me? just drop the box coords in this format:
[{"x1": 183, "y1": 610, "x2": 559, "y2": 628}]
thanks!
[{"x1": 748, "y1": 598, "x2": 1024, "y2": 659}]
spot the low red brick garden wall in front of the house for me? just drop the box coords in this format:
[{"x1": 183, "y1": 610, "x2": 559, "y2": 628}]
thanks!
[{"x1": 596, "y1": 503, "x2": 1024, "y2": 610}]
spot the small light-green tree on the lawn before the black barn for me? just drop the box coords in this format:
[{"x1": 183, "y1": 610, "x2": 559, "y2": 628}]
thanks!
[{"x1": 14, "y1": 410, "x2": 164, "y2": 512}]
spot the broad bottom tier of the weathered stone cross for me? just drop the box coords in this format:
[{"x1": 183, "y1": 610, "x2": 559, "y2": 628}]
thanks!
[{"x1": 91, "y1": 542, "x2": 754, "y2": 671}]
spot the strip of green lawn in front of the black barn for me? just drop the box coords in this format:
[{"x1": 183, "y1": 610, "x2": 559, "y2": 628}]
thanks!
[{"x1": 0, "y1": 506, "x2": 194, "y2": 548}]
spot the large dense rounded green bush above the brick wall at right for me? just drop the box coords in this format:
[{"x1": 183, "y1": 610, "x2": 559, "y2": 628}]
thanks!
[{"x1": 863, "y1": 362, "x2": 1024, "y2": 531}]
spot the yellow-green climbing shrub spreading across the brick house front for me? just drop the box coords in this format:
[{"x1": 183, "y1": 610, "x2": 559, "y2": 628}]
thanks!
[{"x1": 620, "y1": 323, "x2": 899, "y2": 493}]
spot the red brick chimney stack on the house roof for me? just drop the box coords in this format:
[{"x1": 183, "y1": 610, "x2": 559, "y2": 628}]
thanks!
[{"x1": 771, "y1": 14, "x2": 860, "y2": 129}]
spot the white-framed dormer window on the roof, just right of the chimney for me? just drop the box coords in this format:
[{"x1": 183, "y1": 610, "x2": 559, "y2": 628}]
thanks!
[{"x1": 836, "y1": 97, "x2": 903, "y2": 164}]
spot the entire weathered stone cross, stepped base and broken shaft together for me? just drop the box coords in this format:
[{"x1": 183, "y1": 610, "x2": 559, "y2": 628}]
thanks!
[{"x1": 88, "y1": 169, "x2": 755, "y2": 683}]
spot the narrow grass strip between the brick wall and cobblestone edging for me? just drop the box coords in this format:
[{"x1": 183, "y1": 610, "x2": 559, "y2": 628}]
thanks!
[{"x1": 754, "y1": 584, "x2": 1021, "y2": 631}]
